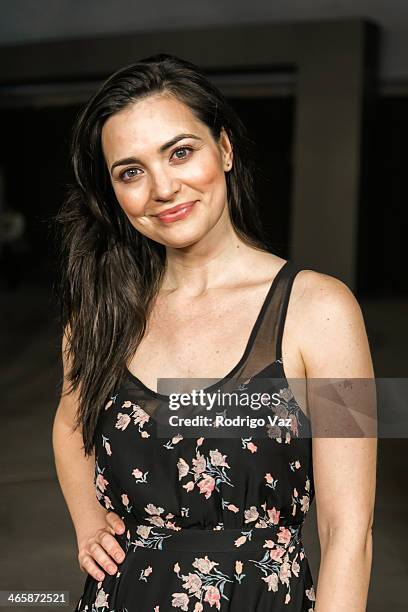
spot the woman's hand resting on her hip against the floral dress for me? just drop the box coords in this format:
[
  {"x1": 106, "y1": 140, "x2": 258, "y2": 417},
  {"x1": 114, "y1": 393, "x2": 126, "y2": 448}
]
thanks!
[{"x1": 78, "y1": 512, "x2": 125, "y2": 581}]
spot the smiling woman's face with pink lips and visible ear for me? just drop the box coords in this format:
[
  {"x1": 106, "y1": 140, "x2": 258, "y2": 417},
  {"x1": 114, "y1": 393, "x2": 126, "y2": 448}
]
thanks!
[{"x1": 102, "y1": 95, "x2": 232, "y2": 248}]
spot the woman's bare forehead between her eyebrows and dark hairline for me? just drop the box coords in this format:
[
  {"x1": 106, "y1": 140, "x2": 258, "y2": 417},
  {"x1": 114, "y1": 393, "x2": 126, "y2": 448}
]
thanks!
[{"x1": 101, "y1": 95, "x2": 206, "y2": 158}]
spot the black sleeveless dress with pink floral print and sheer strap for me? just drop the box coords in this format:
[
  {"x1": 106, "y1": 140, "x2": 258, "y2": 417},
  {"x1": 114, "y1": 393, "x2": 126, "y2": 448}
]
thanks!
[{"x1": 75, "y1": 261, "x2": 315, "y2": 612}]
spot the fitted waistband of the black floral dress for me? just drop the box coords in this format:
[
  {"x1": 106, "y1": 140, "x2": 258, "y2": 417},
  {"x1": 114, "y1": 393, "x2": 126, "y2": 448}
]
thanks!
[{"x1": 115, "y1": 517, "x2": 303, "y2": 552}]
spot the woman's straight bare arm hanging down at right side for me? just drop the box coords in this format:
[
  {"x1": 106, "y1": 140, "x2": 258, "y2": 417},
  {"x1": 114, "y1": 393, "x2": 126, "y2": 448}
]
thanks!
[{"x1": 302, "y1": 271, "x2": 377, "y2": 612}]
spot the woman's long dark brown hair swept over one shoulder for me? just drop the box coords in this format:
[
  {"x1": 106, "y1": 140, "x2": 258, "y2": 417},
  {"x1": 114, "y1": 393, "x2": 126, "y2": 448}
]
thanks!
[{"x1": 55, "y1": 53, "x2": 270, "y2": 456}]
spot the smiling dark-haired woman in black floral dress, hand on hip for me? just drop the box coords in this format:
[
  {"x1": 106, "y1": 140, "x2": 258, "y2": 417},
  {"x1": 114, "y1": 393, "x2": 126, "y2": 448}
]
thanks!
[{"x1": 53, "y1": 54, "x2": 376, "y2": 612}]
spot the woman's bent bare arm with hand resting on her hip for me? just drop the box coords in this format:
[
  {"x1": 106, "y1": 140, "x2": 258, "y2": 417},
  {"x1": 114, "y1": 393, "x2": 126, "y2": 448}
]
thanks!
[{"x1": 52, "y1": 326, "x2": 126, "y2": 580}]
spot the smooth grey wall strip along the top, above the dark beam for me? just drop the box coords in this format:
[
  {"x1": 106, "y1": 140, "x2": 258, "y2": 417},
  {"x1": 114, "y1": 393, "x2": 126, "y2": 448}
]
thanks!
[{"x1": 0, "y1": 0, "x2": 408, "y2": 80}]
